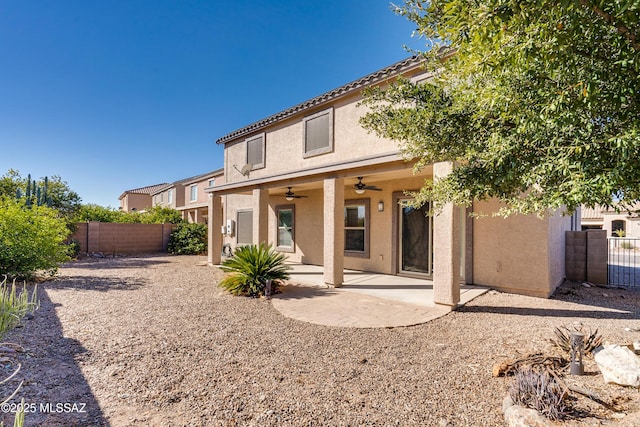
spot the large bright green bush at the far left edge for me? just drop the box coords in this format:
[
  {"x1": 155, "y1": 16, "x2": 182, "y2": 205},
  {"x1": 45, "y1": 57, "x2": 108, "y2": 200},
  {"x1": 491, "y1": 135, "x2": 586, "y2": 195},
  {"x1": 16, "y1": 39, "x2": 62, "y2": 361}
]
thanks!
[{"x1": 0, "y1": 198, "x2": 70, "y2": 279}]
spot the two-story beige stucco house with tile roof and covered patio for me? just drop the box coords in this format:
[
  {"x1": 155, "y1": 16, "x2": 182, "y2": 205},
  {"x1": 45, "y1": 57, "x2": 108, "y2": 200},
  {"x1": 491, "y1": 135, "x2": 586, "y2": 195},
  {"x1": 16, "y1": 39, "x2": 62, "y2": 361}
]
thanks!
[{"x1": 207, "y1": 58, "x2": 577, "y2": 306}]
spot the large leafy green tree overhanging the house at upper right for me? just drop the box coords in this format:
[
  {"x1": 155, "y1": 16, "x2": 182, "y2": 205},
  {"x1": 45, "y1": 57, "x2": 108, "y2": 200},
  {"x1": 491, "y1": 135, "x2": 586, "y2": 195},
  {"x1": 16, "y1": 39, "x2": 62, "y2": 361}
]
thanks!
[{"x1": 361, "y1": 0, "x2": 640, "y2": 215}]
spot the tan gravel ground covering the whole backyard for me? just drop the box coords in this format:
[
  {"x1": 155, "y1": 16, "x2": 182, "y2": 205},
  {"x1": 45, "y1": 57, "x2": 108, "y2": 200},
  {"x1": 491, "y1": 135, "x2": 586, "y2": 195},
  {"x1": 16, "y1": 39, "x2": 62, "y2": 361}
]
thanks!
[{"x1": 2, "y1": 256, "x2": 640, "y2": 426}]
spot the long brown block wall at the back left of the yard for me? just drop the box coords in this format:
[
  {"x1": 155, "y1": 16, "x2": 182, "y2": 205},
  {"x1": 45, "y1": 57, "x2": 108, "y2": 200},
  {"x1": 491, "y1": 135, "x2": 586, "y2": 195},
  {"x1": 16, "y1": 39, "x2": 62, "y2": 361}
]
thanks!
[{"x1": 71, "y1": 222, "x2": 174, "y2": 255}]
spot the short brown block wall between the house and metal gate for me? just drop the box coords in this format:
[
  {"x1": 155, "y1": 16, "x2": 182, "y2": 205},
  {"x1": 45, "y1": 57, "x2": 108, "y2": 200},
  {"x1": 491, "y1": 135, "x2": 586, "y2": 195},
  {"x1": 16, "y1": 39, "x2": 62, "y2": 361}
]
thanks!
[{"x1": 565, "y1": 230, "x2": 608, "y2": 285}]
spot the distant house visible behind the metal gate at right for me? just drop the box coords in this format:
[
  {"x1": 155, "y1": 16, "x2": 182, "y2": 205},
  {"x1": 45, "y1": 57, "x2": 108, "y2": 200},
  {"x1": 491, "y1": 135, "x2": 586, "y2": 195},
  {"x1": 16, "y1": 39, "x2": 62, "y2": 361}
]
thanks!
[{"x1": 581, "y1": 204, "x2": 640, "y2": 238}]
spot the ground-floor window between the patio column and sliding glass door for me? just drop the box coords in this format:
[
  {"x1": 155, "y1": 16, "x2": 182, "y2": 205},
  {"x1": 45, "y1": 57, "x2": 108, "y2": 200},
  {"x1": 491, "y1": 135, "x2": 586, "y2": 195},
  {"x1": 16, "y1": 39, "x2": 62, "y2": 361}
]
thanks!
[{"x1": 344, "y1": 199, "x2": 369, "y2": 258}]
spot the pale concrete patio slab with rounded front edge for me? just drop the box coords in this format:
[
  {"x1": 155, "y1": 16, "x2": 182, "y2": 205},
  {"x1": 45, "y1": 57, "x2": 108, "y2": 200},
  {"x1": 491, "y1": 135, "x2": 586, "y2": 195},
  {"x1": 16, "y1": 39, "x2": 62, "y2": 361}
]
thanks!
[{"x1": 272, "y1": 264, "x2": 488, "y2": 328}]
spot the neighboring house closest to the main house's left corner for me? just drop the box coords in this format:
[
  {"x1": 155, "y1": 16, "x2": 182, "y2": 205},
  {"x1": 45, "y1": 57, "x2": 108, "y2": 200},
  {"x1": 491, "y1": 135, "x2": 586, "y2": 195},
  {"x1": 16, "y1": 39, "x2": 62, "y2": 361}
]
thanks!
[{"x1": 176, "y1": 169, "x2": 224, "y2": 224}]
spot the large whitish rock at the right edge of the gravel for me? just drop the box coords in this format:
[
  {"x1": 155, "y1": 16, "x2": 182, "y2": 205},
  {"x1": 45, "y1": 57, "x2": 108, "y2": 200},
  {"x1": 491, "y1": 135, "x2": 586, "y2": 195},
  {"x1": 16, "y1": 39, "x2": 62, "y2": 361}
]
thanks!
[{"x1": 594, "y1": 345, "x2": 640, "y2": 387}]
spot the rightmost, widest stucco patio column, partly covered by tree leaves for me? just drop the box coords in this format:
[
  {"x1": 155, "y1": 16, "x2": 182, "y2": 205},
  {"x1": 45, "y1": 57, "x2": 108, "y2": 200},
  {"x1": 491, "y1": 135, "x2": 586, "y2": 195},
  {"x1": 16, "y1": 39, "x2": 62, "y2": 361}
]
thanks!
[{"x1": 433, "y1": 162, "x2": 461, "y2": 307}]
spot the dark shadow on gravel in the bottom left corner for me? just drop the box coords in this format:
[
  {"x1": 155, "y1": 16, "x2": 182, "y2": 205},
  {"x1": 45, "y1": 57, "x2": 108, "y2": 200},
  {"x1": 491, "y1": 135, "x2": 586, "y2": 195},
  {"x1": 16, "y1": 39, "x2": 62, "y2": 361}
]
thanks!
[{"x1": 0, "y1": 290, "x2": 109, "y2": 427}]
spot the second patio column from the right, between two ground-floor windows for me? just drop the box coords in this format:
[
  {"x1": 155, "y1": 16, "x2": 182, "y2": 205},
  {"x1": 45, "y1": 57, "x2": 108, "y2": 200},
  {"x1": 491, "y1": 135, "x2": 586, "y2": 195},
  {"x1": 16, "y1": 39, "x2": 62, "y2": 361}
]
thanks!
[{"x1": 323, "y1": 178, "x2": 344, "y2": 287}]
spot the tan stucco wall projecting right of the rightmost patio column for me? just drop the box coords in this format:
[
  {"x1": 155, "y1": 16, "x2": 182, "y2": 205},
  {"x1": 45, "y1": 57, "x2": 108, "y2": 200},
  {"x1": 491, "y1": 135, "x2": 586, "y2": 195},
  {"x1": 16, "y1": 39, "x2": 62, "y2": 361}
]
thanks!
[{"x1": 473, "y1": 201, "x2": 570, "y2": 297}]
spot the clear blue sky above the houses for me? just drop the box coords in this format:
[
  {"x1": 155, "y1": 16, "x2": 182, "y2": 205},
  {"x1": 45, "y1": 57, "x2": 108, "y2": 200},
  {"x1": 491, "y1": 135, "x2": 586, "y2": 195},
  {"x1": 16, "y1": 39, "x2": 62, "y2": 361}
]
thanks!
[{"x1": 0, "y1": 0, "x2": 421, "y2": 207}]
